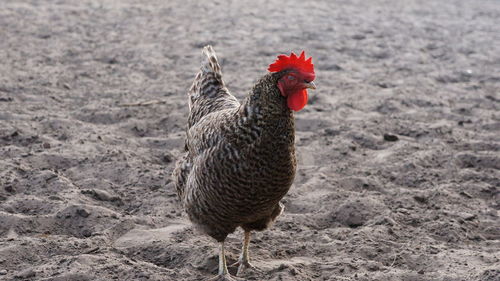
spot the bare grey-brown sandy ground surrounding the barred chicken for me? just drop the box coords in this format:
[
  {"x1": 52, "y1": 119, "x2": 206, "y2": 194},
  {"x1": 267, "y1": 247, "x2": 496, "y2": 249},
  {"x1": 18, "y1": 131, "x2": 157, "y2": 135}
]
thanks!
[{"x1": 0, "y1": 0, "x2": 500, "y2": 281}]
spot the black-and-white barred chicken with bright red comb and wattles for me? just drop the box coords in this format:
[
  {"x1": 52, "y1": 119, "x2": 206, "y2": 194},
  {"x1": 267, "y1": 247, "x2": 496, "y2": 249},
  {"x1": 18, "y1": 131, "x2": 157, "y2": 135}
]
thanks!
[{"x1": 172, "y1": 46, "x2": 316, "y2": 280}]
